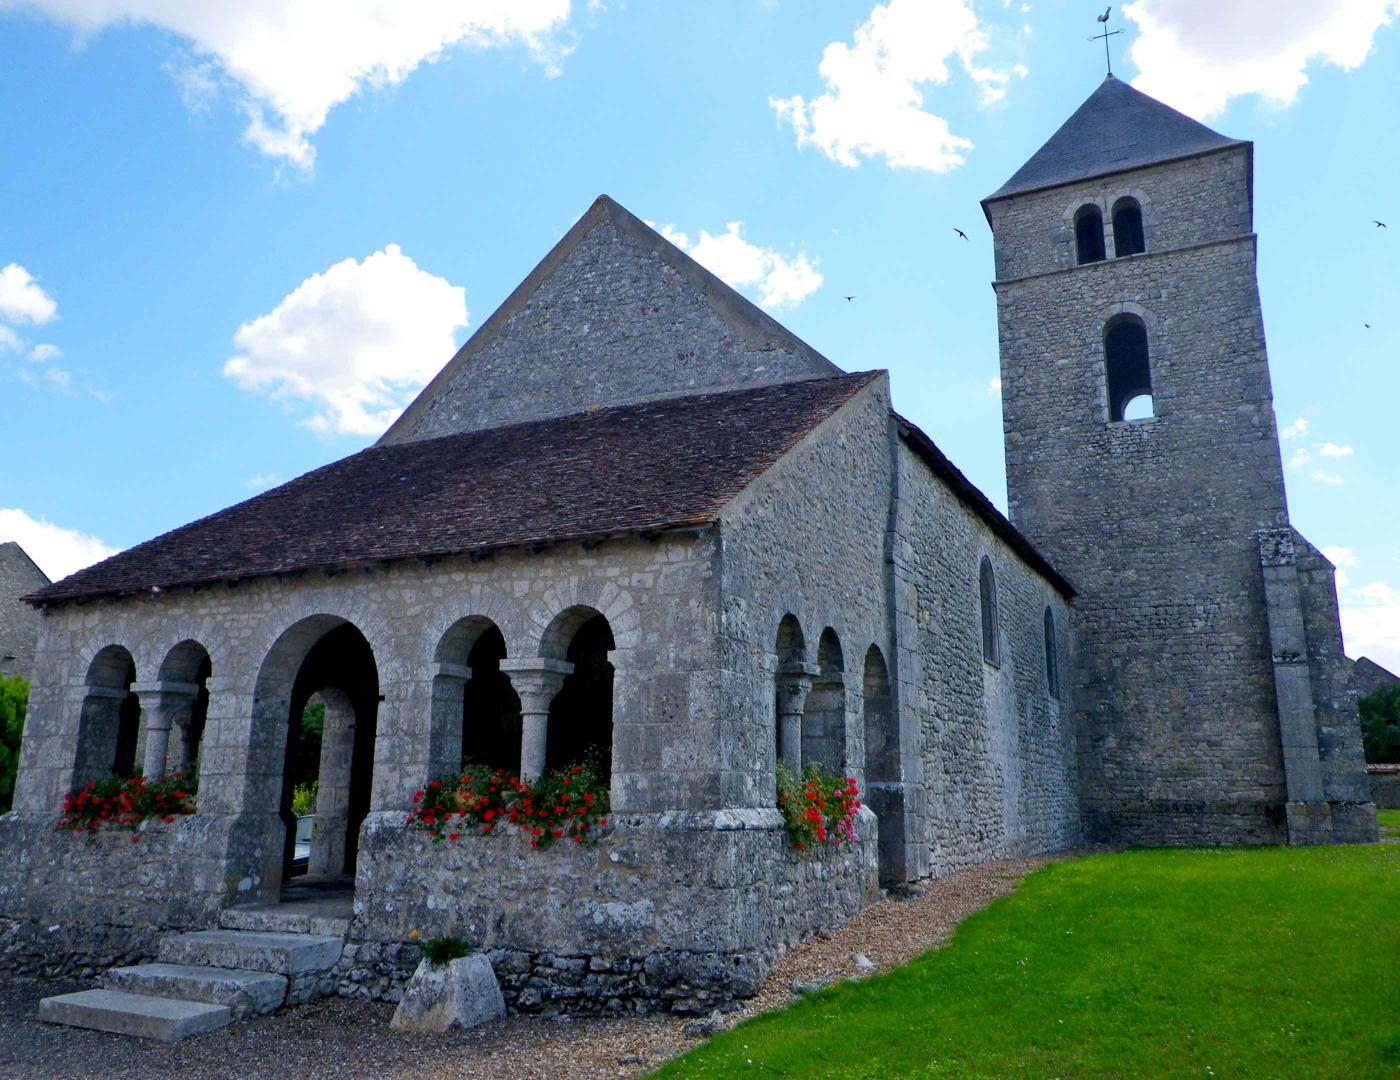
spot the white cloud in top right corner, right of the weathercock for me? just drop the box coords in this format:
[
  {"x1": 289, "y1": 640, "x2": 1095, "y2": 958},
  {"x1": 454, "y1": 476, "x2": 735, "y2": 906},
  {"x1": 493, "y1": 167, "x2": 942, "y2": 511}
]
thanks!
[{"x1": 1123, "y1": 0, "x2": 1400, "y2": 119}]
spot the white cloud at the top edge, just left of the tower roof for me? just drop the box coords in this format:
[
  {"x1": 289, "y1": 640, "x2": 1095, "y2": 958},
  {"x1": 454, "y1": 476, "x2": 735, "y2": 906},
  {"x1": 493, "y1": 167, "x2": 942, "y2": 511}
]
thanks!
[{"x1": 769, "y1": 0, "x2": 1025, "y2": 172}]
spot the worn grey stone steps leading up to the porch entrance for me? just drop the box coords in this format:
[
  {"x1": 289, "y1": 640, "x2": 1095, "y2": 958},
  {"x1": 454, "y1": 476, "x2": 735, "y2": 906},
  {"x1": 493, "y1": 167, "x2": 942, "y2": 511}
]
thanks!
[{"x1": 39, "y1": 885, "x2": 350, "y2": 1042}]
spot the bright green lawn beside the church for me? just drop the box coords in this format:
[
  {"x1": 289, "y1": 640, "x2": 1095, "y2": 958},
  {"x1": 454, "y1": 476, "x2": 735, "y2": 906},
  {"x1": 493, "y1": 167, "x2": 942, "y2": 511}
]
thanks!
[{"x1": 658, "y1": 851, "x2": 1400, "y2": 1080}]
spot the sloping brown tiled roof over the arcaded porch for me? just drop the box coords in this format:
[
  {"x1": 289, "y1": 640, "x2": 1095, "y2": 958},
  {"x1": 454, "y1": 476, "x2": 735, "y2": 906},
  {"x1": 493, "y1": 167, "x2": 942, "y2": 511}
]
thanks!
[{"x1": 28, "y1": 373, "x2": 878, "y2": 604}]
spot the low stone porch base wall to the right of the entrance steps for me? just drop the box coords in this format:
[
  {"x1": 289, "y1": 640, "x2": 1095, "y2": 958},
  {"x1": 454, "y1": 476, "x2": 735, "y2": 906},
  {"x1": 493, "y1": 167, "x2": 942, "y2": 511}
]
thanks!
[{"x1": 347, "y1": 810, "x2": 878, "y2": 1013}]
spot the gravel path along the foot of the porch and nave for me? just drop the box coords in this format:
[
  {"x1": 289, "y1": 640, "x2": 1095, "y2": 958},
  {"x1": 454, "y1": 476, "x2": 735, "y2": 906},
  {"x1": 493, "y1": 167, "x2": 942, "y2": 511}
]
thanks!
[{"x1": 0, "y1": 856, "x2": 1063, "y2": 1080}]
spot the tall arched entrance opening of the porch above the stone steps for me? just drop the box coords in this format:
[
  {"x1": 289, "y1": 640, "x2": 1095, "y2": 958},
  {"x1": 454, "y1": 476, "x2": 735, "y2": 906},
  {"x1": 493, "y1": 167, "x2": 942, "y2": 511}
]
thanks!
[{"x1": 253, "y1": 615, "x2": 379, "y2": 884}]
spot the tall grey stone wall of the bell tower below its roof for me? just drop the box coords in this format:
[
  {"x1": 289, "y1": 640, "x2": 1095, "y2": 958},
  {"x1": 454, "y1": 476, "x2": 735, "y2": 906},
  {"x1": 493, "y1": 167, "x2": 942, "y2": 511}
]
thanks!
[{"x1": 994, "y1": 151, "x2": 1287, "y2": 843}]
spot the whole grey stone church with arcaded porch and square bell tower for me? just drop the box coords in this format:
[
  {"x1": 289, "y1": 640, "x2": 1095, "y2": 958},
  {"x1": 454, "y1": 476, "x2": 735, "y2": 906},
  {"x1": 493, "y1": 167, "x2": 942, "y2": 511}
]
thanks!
[{"x1": 0, "y1": 76, "x2": 1376, "y2": 1010}]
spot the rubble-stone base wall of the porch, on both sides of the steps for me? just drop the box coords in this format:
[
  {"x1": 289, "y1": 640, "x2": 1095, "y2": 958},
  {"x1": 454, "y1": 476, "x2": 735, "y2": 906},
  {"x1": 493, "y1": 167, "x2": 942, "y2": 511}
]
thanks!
[{"x1": 0, "y1": 810, "x2": 878, "y2": 1014}]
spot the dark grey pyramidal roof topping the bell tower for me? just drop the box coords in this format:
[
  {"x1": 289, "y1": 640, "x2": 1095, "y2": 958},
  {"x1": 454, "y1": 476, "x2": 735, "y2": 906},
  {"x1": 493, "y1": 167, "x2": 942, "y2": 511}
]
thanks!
[{"x1": 983, "y1": 74, "x2": 1249, "y2": 206}]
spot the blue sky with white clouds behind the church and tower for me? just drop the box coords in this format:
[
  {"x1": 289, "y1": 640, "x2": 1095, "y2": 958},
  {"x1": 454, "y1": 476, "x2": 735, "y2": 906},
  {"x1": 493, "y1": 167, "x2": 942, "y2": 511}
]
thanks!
[{"x1": 0, "y1": 0, "x2": 1400, "y2": 670}]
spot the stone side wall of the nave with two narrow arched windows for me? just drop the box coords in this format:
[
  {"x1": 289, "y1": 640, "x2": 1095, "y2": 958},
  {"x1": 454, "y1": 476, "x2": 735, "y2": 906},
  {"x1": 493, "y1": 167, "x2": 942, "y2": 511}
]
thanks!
[{"x1": 893, "y1": 444, "x2": 1081, "y2": 875}]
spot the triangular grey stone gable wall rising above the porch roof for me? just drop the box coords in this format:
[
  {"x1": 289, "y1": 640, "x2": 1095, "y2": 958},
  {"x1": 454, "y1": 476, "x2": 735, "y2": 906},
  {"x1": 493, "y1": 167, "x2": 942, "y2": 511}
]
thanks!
[{"x1": 384, "y1": 200, "x2": 840, "y2": 443}]
